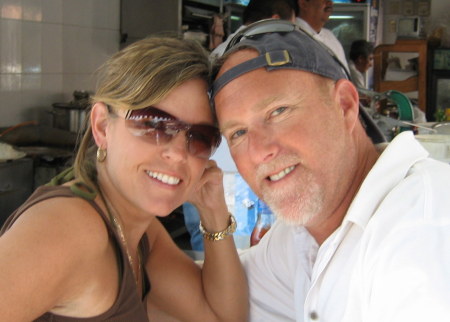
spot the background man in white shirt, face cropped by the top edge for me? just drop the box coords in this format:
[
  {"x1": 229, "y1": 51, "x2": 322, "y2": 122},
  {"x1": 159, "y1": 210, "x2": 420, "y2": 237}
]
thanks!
[{"x1": 296, "y1": 0, "x2": 349, "y2": 71}]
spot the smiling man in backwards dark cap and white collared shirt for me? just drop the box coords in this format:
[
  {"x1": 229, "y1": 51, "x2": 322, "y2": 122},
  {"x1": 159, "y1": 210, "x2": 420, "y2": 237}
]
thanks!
[{"x1": 211, "y1": 21, "x2": 450, "y2": 322}]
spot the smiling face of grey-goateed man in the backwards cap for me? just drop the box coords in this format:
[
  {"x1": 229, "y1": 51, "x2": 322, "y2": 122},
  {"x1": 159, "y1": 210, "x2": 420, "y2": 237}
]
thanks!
[{"x1": 215, "y1": 50, "x2": 351, "y2": 226}]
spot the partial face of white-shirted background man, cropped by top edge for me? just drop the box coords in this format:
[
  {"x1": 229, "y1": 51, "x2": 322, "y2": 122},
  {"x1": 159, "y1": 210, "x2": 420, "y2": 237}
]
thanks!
[{"x1": 299, "y1": 0, "x2": 333, "y2": 29}]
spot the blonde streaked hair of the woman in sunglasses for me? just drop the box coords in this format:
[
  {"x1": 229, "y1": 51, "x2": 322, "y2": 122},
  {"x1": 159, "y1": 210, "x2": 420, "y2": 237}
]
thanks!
[{"x1": 74, "y1": 37, "x2": 210, "y2": 189}]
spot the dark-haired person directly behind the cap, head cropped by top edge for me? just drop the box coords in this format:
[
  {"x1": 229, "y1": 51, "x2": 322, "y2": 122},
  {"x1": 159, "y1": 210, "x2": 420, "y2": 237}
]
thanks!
[{"x1": 211, "y1": 0, "x2": 298, "y2": 58}]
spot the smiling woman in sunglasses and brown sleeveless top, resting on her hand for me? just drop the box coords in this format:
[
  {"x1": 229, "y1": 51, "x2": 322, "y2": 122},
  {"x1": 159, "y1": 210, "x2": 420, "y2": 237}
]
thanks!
[{"x1": 0, "y1": 38, "x2": 247, "y2": 321}]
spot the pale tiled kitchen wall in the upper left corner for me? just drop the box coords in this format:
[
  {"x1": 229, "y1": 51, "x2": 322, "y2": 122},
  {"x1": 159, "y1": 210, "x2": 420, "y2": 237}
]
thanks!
[{"x1": 0, "y1": 0, "x2": 120, "y2": 127}]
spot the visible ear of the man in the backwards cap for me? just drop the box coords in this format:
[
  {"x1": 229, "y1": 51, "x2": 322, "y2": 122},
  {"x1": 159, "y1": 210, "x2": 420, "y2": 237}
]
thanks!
[{"x1": 334, "y1": 79, "x2": 359, "y2": 131}]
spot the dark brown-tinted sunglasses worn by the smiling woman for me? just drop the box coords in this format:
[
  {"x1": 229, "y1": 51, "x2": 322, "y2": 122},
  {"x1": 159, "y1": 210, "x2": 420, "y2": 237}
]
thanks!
[{"x1": 108, "y1": 106, "x2": 222, "y2": 159}]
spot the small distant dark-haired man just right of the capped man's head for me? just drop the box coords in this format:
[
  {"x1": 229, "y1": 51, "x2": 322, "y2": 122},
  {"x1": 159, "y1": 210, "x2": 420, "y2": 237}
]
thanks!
[{"x1": 348, "y1": 39, "x2": 373, "y2": 89}]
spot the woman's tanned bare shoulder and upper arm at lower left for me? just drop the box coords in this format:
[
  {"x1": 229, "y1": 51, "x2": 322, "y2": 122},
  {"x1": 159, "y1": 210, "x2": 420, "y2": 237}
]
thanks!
[{"x1": 0, "y1": 197, "x2": 114, "y2": 316}]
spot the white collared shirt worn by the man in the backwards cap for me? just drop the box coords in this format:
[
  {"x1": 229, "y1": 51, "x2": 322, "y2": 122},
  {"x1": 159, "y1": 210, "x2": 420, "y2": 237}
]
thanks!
[{"x1": 241, "y1": 132, "x2": 450, "y2": 322}]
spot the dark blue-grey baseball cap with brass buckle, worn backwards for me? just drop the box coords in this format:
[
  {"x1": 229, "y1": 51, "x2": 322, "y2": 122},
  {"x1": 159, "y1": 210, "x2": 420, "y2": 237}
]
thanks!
[{"x1": 210, "y1": 19, "x2": 386, "y2": 143}]
